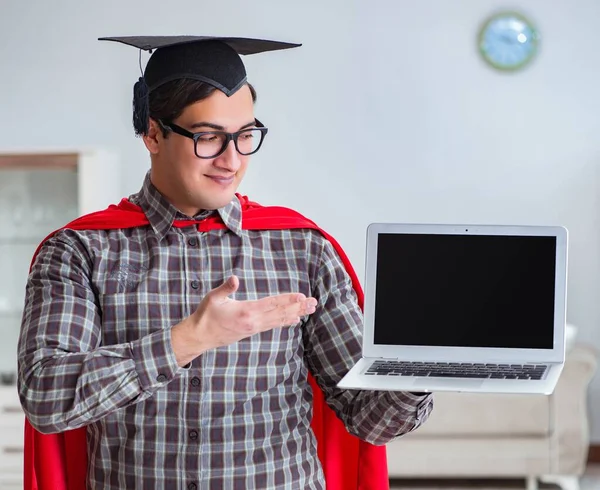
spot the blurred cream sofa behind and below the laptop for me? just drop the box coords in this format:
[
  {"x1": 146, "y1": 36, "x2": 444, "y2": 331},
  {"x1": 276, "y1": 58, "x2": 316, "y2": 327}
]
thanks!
[{"x1": 387, "y1": 336, "x2": 598, "y2": 490}]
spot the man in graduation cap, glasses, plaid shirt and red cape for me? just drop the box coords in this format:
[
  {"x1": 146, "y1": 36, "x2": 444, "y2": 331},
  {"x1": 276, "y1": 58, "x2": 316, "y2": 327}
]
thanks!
[{"x1": 19, "y1": 37, "x2": 432, "y2": 490}]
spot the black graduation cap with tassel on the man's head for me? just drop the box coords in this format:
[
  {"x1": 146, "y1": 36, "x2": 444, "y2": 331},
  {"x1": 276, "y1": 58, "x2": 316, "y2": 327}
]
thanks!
[{"x1": 99, "y1": 36, "x2": 301, "y2": 134}]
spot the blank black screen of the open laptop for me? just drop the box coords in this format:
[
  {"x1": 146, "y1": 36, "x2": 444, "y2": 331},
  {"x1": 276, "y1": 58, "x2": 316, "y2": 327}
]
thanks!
[{"x1": 374, "y1": 233, "x2": 557, "y2": 349}]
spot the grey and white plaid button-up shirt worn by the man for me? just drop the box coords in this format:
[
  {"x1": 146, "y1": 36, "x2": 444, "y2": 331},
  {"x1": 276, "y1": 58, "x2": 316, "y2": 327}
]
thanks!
[{"x1": 19, "y1": 176, "x2": 432, "y2": 490}]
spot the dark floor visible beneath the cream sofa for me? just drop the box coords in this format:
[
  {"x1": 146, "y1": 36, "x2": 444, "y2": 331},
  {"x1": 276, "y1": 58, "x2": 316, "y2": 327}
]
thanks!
[{"x1": 390, "y1": 464, "x2": 600, "y2": 490}]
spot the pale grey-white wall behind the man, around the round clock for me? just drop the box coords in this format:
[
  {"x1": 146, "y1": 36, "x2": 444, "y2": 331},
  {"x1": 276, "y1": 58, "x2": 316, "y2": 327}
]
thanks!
[{"x1": 0, "y1": 0, "x2": 600, "y2": 443}]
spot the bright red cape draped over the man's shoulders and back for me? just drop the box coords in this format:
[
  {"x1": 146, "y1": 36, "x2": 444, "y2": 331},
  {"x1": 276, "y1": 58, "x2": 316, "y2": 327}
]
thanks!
[{"x1": 24, "y1": 195, "x2": 389, "y2": 490}]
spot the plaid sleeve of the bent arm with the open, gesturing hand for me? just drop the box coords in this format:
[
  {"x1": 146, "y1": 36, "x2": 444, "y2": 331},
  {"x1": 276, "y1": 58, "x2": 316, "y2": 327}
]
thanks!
[{"x1": 18, "y1": 234, "x2": 182, "y2": 433}]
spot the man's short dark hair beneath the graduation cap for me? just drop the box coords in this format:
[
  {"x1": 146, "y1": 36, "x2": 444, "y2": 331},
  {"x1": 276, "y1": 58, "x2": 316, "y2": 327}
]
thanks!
[{"x1": 149, "y1": 78, "x2": 257, "y2": 137}]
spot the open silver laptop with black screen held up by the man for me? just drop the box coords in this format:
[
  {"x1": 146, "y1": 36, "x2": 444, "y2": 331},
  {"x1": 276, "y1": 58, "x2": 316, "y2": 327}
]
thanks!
[{"x1": 338, "y1": 223, "x2": 568, "y2": 394}]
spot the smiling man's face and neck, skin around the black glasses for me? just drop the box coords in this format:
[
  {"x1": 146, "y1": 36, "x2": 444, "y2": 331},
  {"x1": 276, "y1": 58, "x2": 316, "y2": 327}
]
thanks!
[{"x1": 144, "y1": 86, "x2": 254, "y2": 216}]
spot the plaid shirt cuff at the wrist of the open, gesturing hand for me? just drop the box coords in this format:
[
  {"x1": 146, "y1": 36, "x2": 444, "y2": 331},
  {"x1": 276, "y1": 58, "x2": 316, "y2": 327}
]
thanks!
[{"x1": 131, "y1": 327, "x2": 182, "y2": 391}]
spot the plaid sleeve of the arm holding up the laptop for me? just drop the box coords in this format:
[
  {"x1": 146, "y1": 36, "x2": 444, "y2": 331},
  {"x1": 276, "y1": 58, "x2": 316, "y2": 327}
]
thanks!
[{"x1": 304, "y1": 235, "x2": 433, "y2": 445}]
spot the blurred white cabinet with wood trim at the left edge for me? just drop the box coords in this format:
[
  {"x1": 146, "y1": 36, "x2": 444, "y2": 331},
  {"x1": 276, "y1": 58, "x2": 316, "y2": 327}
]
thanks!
[{"x1": 0, "y1": 151, "x2": 122, "y2": 490}]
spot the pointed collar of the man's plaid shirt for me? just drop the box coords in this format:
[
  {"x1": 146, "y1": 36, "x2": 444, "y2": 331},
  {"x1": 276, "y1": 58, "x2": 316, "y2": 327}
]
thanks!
[{"x1": 129, "y1": 171, "x2": 242, "y2": 239}]
